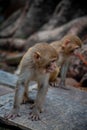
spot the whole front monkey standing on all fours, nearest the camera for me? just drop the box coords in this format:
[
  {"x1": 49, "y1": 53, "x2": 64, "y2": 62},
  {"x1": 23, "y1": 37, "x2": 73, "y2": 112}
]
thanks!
[{"x1": 5, "y1": 43, "x2": 58, "y2": 120}]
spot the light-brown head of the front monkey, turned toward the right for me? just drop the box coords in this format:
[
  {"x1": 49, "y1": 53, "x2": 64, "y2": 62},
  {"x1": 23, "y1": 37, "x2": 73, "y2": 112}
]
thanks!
[{"x1": 33, "y1": 43, "x2": 58, "y2": 73}]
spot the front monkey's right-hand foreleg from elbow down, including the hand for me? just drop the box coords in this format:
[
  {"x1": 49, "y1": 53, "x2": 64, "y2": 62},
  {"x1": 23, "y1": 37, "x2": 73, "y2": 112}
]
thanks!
[{"x1": 30, "y1": 84, "x2": 48, "y2": 121}]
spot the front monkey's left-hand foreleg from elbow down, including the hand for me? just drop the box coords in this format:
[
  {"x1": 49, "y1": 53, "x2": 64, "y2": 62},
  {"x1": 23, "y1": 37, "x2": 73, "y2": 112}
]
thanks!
[{"x1": 5, "y1": 83, "x2": 24, "y2": 119}]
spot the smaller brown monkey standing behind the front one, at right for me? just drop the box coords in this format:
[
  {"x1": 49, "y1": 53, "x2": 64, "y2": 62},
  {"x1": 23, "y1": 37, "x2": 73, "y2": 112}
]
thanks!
[{"x1": 49, "y1": 35, "x2": 82, "y2": 89}]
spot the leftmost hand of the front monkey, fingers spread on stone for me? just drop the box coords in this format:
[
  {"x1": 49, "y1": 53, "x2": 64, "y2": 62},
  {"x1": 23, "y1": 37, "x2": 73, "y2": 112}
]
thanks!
[{"x1": 4, "y1": 109, "x2": 20, "y2": 120}]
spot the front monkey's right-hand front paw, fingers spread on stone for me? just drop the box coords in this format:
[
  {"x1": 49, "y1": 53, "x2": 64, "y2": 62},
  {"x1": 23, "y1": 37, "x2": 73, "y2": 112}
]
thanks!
[{"x1": 29, "y1": 107, "x2": 40, "y2": 121}]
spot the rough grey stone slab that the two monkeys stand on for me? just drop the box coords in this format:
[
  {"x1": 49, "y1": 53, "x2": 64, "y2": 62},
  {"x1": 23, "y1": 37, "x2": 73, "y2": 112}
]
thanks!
[{"x1": 0, "y1": 86, "x2": 87, "y2": 130}]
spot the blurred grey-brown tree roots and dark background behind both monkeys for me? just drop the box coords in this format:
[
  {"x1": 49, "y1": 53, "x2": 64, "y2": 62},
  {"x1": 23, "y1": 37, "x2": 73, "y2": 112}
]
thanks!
[{"x1": 0, "y1": 0, "x2": 87, "y2": 87}]
